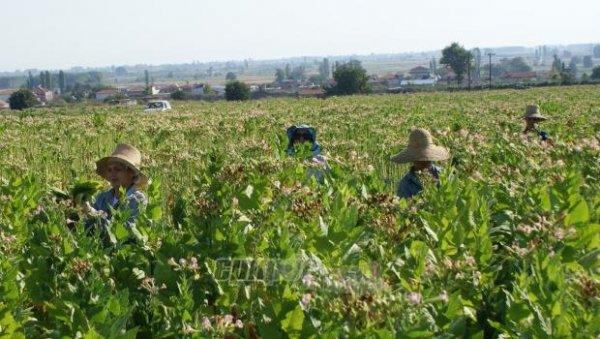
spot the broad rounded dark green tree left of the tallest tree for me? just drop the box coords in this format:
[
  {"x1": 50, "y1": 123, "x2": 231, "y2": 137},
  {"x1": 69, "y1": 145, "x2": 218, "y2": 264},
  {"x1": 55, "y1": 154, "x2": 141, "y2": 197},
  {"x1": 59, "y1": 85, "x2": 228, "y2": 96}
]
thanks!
[{"x1": 326, "y1": 60, "x2": 371, "y2": 95}]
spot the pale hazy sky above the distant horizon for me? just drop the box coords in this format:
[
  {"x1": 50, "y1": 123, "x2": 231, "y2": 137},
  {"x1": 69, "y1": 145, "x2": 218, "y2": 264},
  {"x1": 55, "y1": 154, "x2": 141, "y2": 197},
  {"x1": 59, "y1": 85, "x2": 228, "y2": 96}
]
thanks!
[{"x1": 0, "y1": 0, "x2": 600, "y2": 71}]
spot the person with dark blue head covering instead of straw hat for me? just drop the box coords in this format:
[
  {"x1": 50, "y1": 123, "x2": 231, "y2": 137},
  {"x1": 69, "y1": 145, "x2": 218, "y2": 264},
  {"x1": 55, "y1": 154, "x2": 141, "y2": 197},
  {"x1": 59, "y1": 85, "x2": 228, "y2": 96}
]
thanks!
[{"x1": 285, "y1": 125, "x2": 329, "y2": 183}]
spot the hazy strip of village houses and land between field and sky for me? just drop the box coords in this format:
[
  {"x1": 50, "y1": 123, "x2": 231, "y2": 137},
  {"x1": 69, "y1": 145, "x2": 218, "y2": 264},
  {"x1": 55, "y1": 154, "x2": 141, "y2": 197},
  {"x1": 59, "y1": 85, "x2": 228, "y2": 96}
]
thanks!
[{"x1": 0, "y1": 44, "x2": 600, "y2": 109}]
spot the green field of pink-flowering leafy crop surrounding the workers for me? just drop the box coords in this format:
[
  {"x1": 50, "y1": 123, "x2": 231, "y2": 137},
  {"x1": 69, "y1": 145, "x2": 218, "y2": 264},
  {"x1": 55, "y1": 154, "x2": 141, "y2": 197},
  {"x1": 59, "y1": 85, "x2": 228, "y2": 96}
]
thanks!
[{"x1": 0, "y1": 86, "x2": 600, "y2": 338}]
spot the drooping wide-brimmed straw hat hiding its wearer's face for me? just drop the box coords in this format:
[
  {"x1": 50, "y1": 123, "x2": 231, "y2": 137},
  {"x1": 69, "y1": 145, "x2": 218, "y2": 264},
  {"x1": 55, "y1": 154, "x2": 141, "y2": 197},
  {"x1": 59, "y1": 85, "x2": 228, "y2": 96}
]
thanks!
[{"x1": 390, "y1": 128, "x2": 450, "y2": 164}]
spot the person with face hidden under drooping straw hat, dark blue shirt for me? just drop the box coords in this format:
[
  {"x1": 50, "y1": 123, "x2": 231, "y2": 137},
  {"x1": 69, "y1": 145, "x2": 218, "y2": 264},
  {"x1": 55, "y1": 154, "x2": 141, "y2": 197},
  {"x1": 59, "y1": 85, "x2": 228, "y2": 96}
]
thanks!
[{"x1": 390, "y1": 128, "x2": 450, "y2": 199}]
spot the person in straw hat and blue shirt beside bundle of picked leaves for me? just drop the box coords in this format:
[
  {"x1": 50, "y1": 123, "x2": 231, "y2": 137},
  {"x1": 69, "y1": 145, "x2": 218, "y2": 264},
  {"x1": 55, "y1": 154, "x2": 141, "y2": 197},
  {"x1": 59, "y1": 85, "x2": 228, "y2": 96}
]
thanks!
[{"x1": 86, "y1": 144, "x2": 148, "y2": 228}]
